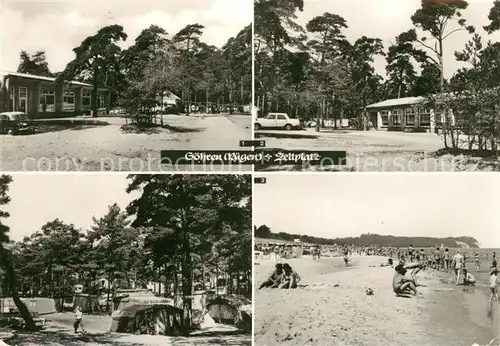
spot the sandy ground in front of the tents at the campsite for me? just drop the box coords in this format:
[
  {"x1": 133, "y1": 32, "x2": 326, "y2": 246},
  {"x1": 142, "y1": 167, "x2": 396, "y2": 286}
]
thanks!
[{"x1": 0, "y1": 313, "x2": 252, "y2": 346}]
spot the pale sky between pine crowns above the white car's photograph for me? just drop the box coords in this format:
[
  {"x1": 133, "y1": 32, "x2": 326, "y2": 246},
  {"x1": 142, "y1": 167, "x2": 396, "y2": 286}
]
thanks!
[{"x1": 297, "y1": 0, "x2": 500, "y2": 78}]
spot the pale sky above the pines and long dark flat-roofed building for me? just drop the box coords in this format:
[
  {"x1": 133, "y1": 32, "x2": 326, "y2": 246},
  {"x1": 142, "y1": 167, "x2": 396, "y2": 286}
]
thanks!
[{"x1": 0, "y1": 0, "x2": 253, "y2": 72}]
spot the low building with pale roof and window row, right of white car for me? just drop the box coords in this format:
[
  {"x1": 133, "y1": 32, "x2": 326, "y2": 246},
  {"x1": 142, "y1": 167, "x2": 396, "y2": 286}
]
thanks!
[{"x1": 366, "y1": 96, "x2": 455, "y2": 132}]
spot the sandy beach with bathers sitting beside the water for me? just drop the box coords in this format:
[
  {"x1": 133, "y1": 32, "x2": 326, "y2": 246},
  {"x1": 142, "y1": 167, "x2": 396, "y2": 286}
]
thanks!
[{"x1": 255, "y1": 256, "x2": 496, "y2": 346}]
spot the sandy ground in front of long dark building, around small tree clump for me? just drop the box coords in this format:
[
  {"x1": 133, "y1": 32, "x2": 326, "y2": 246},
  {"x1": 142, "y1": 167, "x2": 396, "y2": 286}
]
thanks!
[{"x1": 0, "y1": 115, "x2": 251, "y2": 172}]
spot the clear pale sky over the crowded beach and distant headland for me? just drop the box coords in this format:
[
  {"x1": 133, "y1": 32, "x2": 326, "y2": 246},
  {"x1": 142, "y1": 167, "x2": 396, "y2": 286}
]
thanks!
[{"x1": 254, "y1": 173, "x2": 500, "y2": 248}]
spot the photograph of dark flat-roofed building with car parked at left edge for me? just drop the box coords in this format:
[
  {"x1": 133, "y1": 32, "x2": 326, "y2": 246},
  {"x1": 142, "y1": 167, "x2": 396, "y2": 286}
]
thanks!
[{"x1": 0, "y1": 0, "x2": 253, "y2": 172}]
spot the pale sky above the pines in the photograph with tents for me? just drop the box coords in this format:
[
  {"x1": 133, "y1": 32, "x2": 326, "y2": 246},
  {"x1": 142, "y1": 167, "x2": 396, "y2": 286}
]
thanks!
[{"x1": 2, "y1": 173, "x2": 139, "y2": 241}]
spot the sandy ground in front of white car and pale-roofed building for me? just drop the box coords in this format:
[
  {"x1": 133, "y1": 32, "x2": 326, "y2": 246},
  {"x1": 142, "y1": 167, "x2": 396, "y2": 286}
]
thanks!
[{"x1": 255, "y1": 129, "x2": 500, "y2": 172}]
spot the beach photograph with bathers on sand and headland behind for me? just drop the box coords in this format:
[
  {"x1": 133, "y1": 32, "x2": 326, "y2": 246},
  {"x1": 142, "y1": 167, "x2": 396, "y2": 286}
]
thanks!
[{"x1": 253, "y1": 173, "x2": 500, "y2": 346}]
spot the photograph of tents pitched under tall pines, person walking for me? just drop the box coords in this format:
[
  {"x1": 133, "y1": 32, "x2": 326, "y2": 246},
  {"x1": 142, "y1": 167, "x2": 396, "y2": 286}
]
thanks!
[{"x1": 0, "y1": 173, "x2": 252, "y2": 346}]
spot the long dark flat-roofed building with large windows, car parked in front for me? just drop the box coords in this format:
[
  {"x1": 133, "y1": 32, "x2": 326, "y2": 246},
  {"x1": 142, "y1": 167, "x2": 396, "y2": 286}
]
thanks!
[{"x1": 0, "y1": 72, "x2": 110, "y2": 119}]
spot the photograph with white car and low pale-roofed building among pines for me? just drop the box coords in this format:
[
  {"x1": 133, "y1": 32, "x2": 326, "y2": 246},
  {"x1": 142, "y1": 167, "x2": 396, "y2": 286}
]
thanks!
[{"x1": 254, "y1": 0, "x2": 500, "y2": 172}]
